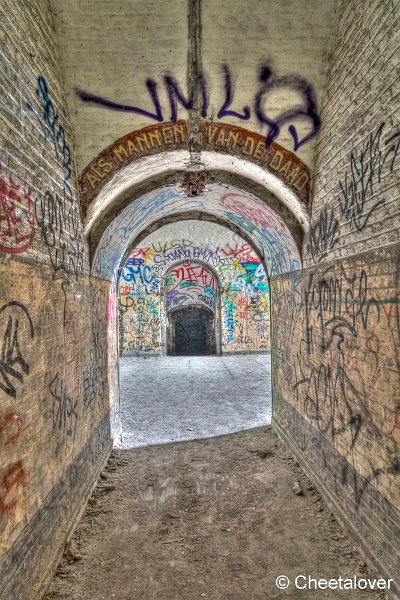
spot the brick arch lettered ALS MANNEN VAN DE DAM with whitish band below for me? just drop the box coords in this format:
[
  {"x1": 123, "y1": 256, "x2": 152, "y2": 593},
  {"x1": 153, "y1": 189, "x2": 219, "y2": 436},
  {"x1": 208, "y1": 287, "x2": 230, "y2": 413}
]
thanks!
[{"x1": 80, "y1": 121, "x2": 310, "y2": 268}]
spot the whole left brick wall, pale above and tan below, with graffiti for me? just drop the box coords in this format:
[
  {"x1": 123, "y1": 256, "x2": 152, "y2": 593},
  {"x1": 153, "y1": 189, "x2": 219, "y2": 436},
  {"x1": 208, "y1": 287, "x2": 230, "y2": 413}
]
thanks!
[{"x1": 0, "y1": 0, "x2": 110, "y2": 600}]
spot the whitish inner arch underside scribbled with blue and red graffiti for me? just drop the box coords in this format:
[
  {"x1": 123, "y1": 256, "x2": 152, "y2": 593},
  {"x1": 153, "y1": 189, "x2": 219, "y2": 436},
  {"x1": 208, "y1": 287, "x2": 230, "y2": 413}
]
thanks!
[{"x1": 92, "y1": 183, "x2": 301, "y2": 281}]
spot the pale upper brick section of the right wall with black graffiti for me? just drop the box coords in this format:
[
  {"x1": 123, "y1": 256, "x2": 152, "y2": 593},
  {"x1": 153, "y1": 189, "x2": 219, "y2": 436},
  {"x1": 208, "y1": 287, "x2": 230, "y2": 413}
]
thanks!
[{"x1": 306, "y1": 0, "x2": 400, "y2": 264}]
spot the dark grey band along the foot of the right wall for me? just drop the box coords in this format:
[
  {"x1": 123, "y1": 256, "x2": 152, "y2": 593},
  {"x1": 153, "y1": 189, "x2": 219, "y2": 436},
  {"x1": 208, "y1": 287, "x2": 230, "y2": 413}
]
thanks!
[{"x1": 273, "y1": 394, "x2": 400, "y2": 593}]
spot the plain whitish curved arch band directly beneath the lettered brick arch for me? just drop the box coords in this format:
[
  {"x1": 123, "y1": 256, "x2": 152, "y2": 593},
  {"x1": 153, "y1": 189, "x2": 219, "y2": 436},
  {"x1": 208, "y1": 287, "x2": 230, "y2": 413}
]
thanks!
[{"x1": 85, "y1": 149, "x2": 309, "y2": 256}]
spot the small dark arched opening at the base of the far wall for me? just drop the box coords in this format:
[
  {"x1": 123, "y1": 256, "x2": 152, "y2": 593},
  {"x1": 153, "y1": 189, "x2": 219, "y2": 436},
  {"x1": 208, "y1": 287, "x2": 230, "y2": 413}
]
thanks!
[{"x1": 167, "y1": 305, "x2": 216, "y2": 356}]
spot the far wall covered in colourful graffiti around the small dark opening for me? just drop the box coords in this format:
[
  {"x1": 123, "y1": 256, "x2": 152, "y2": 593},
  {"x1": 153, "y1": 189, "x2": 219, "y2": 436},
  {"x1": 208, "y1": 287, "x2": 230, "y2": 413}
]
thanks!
[{"x1": 119, "y1": 221, "x2": 269, "y2": 353}]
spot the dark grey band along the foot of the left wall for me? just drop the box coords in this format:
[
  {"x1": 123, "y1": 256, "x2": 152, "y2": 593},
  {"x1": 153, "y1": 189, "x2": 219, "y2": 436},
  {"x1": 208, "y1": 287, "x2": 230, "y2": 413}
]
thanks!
[{"x1": 0, "y1": 414, "x2": 112, "y2": 600}]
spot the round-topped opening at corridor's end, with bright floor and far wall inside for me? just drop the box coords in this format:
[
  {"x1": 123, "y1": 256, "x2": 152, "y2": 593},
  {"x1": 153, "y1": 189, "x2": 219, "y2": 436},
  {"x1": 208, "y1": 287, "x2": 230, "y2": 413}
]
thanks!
[{"x1": 118, "y1": 218, "x2": 271, "y2": 447}]
